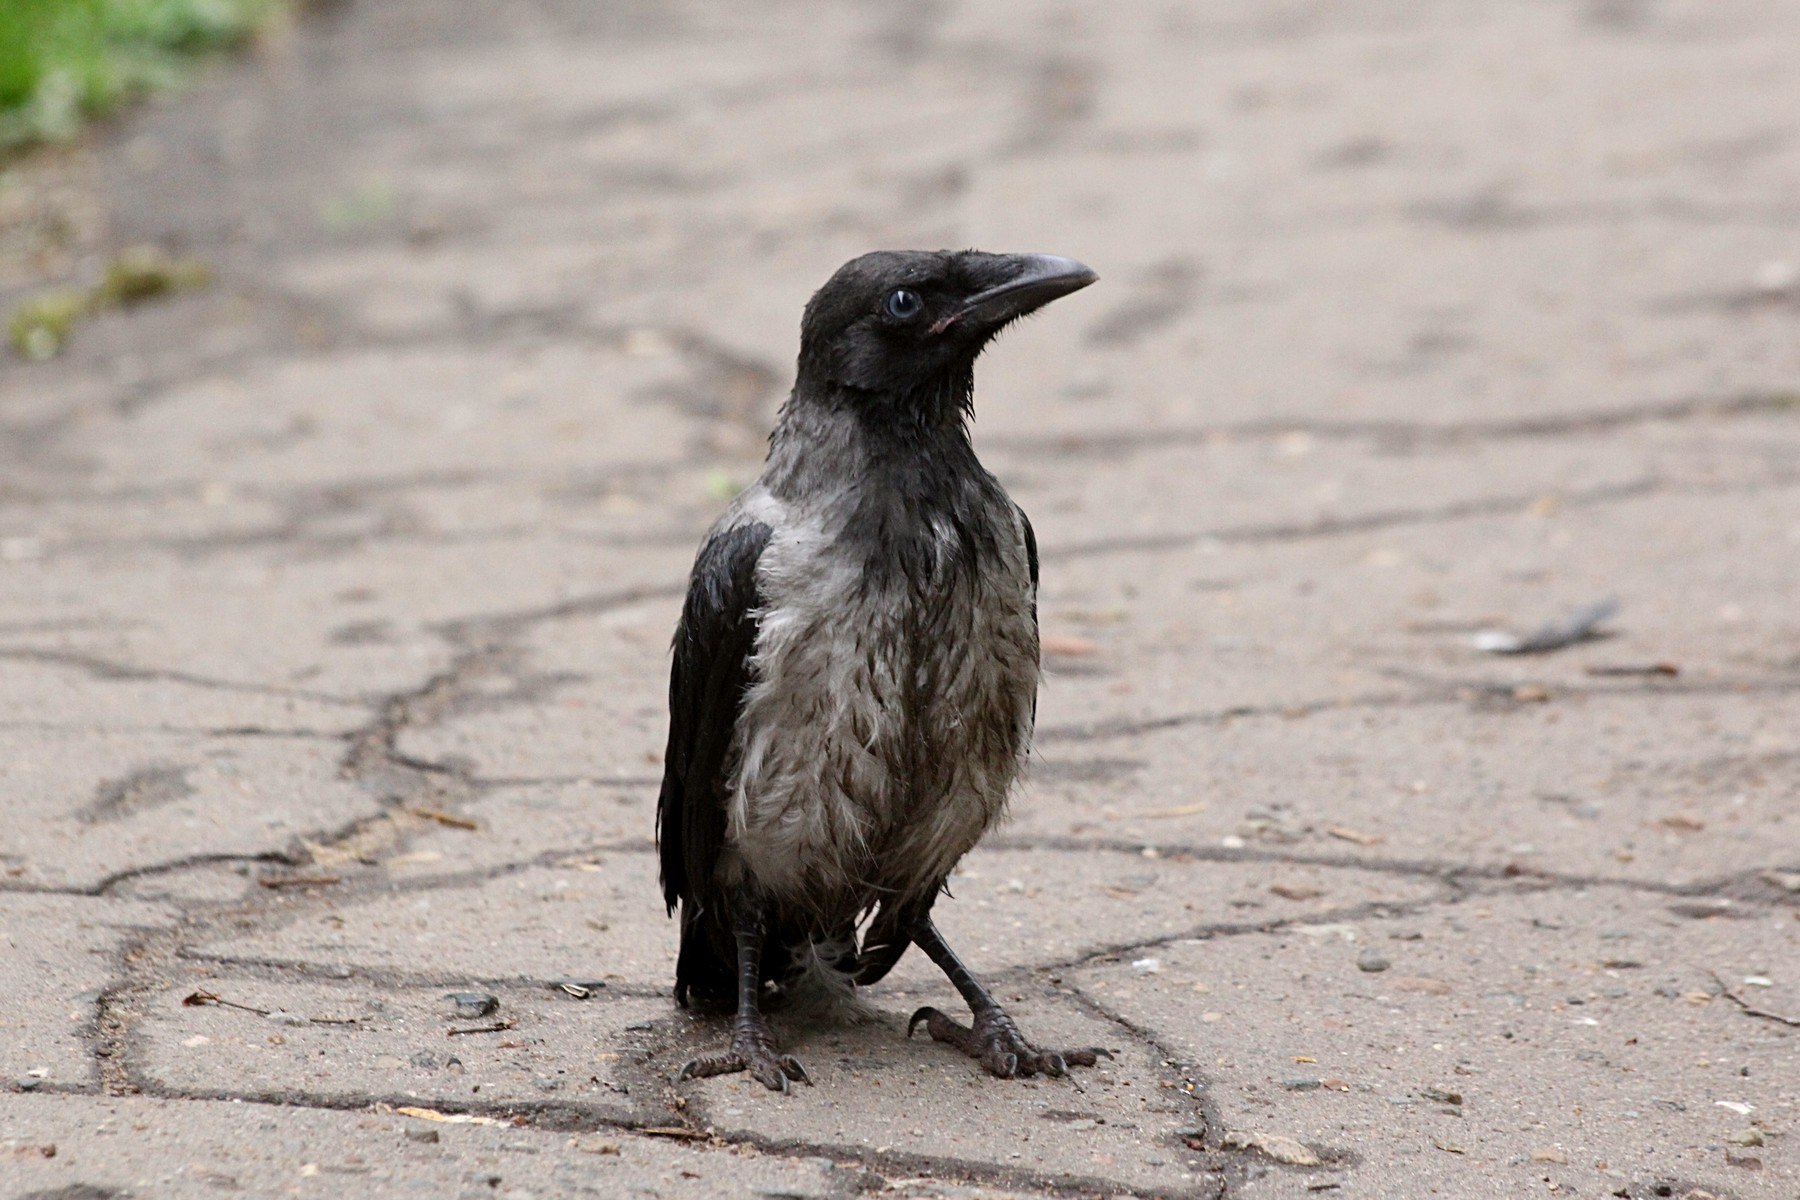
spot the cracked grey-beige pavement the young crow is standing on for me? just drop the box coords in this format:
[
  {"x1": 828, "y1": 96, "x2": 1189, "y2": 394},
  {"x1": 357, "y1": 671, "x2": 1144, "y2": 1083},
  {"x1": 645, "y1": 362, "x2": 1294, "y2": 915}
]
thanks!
[{"x1": 0, "y1": 0, "x2": 1800, "y2": 1200}]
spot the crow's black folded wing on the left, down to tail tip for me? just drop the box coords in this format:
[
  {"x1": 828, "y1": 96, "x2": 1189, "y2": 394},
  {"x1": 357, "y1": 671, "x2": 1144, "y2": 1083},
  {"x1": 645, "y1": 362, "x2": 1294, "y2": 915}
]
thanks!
[{"x1": 657, "y1": 522, "x2": 770, "y2": 997}]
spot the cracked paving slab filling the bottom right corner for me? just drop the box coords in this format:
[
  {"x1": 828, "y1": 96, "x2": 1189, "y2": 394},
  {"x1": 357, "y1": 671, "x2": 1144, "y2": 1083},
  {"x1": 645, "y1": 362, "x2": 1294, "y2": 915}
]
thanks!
[{"x1": 1076, "y1": 887, "x2": 1800, "y2": 1196}]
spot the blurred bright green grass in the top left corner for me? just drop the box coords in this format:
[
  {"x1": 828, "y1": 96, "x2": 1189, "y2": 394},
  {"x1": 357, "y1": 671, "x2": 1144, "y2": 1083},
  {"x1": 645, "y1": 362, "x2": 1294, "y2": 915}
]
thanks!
[{"x1": 0, "y1": 0, "x2": 279, "y2": 157}]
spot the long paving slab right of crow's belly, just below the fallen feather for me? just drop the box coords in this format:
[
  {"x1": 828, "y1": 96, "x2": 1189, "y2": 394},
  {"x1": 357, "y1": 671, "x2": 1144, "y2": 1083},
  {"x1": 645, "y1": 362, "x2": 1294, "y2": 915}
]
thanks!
[{"x1": 1012, "y1": 691, "x2": 1800, "y2": 889}]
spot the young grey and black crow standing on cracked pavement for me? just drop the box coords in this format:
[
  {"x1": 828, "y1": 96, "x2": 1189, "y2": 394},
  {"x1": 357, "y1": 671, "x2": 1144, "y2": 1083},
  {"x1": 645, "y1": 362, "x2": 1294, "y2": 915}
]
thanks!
[{"x1": 657, "y1": 250, "x2": 1103, "y2": 1090}]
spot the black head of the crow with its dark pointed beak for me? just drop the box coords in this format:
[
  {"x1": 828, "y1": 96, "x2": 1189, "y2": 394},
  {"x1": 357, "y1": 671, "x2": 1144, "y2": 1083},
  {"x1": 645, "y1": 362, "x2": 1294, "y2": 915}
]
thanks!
[{"x1": 799, "y1": 250, "x2": 1096, "y2": 408}]
